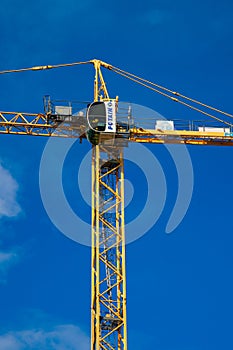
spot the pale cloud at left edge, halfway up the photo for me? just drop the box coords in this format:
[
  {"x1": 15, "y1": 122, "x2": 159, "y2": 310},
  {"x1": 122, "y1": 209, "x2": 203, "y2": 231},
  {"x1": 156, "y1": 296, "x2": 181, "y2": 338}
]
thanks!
[{"x1": 0, "y1": 164, "x2": 21, "y2": 217}]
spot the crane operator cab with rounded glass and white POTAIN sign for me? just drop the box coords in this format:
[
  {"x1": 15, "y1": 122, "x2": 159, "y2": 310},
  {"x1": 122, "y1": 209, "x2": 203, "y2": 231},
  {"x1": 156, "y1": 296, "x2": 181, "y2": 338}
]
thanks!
[{"x1": 87, "y1": 100, "x2": 130, "y2": 145}]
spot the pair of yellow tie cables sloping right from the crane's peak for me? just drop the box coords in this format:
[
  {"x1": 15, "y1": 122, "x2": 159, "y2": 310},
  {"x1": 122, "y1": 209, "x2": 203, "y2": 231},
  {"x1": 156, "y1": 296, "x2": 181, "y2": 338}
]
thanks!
[{"x1": 111, "y1": 66, "x2": 233, "y2": 126}]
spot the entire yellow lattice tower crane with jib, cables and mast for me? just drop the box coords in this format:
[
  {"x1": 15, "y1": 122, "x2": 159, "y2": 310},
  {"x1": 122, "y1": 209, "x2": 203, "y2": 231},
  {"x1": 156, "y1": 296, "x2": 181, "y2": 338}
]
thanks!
[{"x1": 0, "y1": 59, "x2": 233, "y2": 350}]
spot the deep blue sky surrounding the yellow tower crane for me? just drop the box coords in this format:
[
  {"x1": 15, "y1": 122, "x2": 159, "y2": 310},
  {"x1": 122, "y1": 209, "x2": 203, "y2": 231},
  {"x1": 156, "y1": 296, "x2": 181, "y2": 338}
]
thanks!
[{"x1": 0, "y1": 0, "x2": 233, "y2": 350}]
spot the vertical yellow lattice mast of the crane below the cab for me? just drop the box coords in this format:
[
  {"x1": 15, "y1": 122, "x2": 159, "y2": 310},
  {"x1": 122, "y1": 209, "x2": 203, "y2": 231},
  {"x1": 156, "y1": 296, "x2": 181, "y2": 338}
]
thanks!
[{"x1": 91, "y1": 145, "x2": 127, "y2": 350}]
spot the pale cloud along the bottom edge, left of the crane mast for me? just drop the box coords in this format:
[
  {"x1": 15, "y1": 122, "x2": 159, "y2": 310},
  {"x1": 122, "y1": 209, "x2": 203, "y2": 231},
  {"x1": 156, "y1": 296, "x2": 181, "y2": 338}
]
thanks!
[{"x1": 0, "y1": 324, "x2": 90, "y2": 350}]
